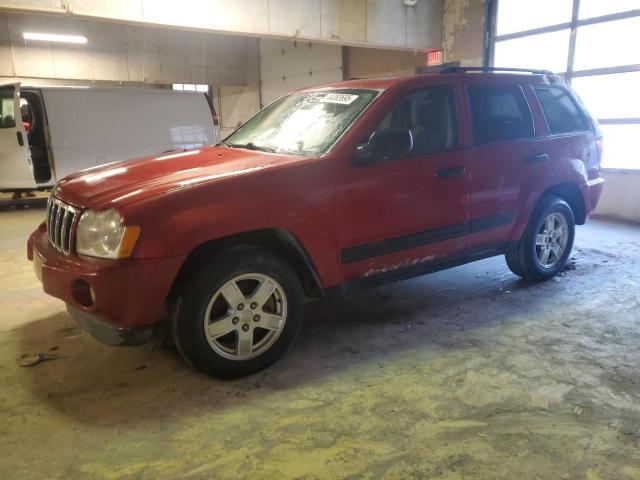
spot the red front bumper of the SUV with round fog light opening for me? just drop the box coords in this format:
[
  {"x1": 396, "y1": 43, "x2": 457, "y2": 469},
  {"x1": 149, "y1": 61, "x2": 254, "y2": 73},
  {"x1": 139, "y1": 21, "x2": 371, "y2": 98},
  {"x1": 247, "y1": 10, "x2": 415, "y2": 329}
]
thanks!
[{"x1": 27, "y1": 225, "x2": 185, "y2": 345}]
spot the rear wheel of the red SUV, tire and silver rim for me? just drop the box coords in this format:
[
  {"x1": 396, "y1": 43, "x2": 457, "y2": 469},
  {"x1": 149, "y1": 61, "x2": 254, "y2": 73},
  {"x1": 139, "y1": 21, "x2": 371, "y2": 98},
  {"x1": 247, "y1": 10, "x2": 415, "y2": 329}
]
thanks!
[{"x1": 505, "y1": 196, "x2": 576, "y2": 282}]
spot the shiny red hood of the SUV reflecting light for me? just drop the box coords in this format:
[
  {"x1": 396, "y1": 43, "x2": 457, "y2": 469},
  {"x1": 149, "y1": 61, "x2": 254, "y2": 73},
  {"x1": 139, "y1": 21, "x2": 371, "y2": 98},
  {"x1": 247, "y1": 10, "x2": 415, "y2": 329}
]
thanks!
[{"x1": 54, "y1": 147, "x2": 306, "y2": 208}]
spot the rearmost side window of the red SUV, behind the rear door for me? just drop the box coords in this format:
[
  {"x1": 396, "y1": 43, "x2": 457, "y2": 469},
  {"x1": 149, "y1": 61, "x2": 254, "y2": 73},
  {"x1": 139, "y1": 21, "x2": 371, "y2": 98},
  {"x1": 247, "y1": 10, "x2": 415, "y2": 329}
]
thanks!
[{"x1": 535, "y1": 87, "x2": 588, "y2": 134}]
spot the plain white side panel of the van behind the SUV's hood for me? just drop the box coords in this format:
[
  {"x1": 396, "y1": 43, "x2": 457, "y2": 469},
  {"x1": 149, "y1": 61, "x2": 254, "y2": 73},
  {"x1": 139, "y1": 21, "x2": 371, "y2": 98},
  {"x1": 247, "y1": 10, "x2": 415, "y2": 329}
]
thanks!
[{"x1": 42, "y1": 88, "x2": 217, "y2": 180}]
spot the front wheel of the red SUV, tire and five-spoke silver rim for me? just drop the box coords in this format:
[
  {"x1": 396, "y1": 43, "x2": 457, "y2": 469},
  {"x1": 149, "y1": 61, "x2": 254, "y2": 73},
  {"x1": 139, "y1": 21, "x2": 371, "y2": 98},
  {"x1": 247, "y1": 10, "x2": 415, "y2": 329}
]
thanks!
[{"x1": 172, "y1": 248, "x2": 304, "y2": 378}]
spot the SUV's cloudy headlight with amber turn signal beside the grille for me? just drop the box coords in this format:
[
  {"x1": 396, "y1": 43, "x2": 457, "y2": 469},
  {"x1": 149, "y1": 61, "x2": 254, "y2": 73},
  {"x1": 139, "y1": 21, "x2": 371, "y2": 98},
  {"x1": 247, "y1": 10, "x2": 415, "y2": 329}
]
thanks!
[{"x1": 76, "y1": 208, "x2": 140, "y2": 258}]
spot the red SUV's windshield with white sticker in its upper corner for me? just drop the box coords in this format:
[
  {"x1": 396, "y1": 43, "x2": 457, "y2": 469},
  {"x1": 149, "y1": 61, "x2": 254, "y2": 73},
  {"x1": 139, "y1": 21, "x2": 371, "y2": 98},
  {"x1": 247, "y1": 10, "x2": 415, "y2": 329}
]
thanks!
[{"x1": 224, "y1": 89, "x2": 378, "y2": 156}]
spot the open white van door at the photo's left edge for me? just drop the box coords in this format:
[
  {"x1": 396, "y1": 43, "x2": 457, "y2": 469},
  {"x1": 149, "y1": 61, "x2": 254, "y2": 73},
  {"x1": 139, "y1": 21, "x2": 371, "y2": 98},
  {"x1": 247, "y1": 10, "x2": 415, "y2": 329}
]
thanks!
[{"x1": 0, "y1": 83, "x2": 36, "y2": 191}]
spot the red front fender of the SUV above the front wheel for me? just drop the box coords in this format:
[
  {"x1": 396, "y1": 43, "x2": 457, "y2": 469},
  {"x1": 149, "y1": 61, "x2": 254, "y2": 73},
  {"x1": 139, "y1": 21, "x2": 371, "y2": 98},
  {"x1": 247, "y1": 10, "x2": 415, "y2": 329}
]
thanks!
[{"x1": 124, "y1": 157, "x2": 339, "y2": 287}]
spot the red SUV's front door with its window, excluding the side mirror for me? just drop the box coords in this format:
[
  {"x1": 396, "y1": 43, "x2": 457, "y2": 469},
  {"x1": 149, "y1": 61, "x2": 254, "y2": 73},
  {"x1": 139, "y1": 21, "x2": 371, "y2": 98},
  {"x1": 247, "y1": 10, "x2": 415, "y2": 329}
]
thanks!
[{"x1": 337, "y1": 86, "x2": 467, "y2": 282}]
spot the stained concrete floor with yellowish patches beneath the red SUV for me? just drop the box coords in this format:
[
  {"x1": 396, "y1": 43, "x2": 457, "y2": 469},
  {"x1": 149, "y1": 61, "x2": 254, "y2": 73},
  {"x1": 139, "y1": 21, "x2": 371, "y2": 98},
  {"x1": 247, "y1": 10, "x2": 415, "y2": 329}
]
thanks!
[{"x1": 0, "y1": 210, "x2": 640, "y2": 480}]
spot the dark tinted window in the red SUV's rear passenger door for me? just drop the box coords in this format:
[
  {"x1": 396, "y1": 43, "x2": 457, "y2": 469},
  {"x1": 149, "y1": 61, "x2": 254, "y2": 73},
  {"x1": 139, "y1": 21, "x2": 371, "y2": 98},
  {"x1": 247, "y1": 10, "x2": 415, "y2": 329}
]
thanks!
[{"x1": 468, "y1": 85, "x2": 534, "y2": 144}]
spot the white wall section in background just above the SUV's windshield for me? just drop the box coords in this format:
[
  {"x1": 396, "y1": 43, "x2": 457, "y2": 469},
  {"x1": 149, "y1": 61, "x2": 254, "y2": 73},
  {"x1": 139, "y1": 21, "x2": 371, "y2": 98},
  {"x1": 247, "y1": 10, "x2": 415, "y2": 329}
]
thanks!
[{"x1": 259, "y1": 39, "x2": 342, "y2": 106}]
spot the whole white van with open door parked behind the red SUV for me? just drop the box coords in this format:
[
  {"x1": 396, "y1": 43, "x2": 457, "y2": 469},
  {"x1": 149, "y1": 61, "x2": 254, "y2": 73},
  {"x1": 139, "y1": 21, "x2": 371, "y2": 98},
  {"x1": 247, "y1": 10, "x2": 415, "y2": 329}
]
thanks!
[{"x1": 0, "y1": 83, "x2": 220, "y2": 192}]
